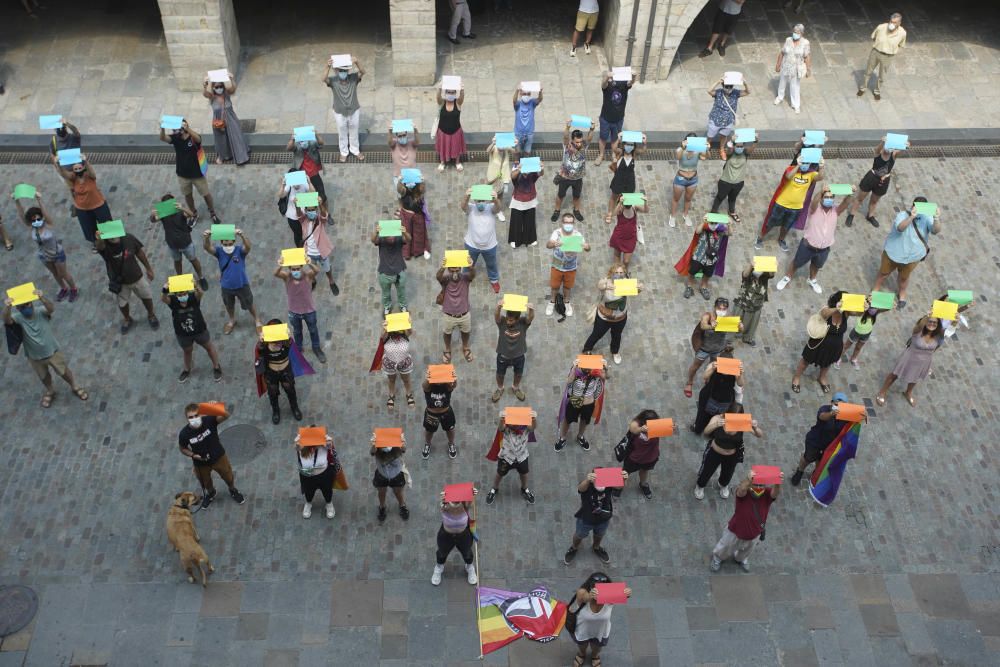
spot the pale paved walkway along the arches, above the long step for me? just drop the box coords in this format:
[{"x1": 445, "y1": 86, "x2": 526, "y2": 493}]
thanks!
[{"x1": 0, "y1": 0, "x2": 1000, "y2": 137}]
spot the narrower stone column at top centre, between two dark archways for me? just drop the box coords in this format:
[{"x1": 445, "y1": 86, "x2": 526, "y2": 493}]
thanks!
[{"x1": 389, "y1": 0, "x2": 437, "y2": 86}]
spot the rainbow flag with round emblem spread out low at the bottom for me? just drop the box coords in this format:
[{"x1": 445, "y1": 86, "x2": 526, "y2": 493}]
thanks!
[{"x1": 478, "y1": 586, "x2": 566, "y2": 655}]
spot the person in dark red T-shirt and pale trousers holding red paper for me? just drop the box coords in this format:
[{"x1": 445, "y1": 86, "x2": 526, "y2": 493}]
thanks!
[{"x1": 710, "y1": 469, "x2": 784, "y2": 572}]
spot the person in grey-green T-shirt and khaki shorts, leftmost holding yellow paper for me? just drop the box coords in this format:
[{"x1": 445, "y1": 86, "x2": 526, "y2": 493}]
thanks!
[{"x1": 3, "y1": 289, "x2": 89, "y2": 408}]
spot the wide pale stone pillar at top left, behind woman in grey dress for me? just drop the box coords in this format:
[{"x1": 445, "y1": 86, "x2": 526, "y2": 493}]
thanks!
[{"x1": 157, "y1": 0, "x2": 240, "y2": 91}]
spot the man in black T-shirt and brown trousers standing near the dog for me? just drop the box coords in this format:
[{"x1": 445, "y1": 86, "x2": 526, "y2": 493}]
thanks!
[{"x1": 177, "y1": 403, "x2": 247, "y2": 509}]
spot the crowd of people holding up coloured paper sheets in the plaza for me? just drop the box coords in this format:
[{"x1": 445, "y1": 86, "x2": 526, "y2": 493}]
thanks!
[{"x1": 0, "y1": 6, "x2": 971, "y2": 664}]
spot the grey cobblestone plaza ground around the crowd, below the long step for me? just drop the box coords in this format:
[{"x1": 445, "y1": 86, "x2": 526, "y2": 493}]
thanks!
[{"x1": 0, "y1": 159, "x2": 1000, "y2": 666}]
